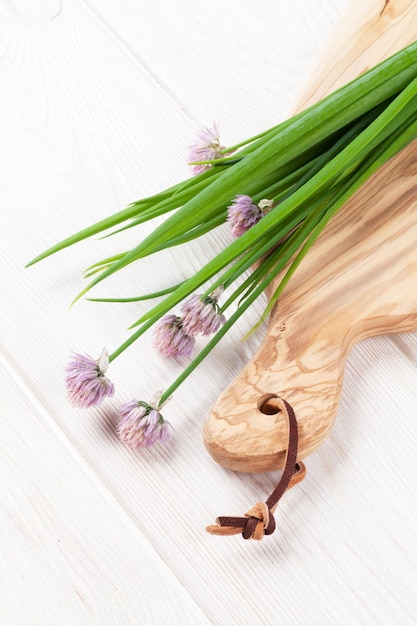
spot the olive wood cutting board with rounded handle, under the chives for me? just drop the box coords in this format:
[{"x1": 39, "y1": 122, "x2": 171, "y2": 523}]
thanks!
[{"x1": 203, "y1": 0, "x2": 417, "y2": 472}]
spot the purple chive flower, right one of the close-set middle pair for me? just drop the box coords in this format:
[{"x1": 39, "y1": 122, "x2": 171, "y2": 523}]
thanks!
[{"x1": 181, "y1": 290, "x2": 226, "y2": 336}]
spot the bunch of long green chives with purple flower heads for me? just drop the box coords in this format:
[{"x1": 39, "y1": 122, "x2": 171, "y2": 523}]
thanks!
[{"x1": 28, "y1": 42, "x2": 417, "y2": 447}]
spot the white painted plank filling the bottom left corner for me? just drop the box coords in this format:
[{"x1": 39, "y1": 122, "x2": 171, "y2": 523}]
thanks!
[{"x1": 0, "y1": 360, "x2": 209, "y2": 626}]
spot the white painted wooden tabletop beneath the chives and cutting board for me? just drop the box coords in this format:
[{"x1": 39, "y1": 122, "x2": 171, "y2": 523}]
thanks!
[{"x1": 0, "y1": 0, "x2": 417, "y2": 626}]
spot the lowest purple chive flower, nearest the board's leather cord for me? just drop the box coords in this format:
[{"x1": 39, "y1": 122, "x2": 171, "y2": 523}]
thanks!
[{"x1": 117, "y1": 400, "x2": 171, "y2": 448}]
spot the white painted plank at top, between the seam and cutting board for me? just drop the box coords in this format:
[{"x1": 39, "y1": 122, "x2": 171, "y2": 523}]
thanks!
[{"x1": 84, "y1": 0, "x2": 346, "y2": 137}]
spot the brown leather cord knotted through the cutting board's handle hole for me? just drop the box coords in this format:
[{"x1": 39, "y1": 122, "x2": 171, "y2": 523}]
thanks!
[{"x1": 206, "y1": 397, "x2": 306, "y2": 540}]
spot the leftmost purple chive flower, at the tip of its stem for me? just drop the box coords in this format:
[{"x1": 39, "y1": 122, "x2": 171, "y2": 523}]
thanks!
[{"x1": 66, "y1": 348, "x2": 114, "y2": 408}]
